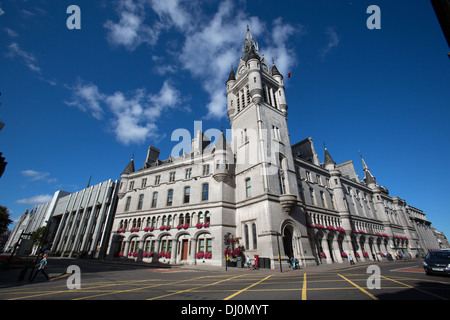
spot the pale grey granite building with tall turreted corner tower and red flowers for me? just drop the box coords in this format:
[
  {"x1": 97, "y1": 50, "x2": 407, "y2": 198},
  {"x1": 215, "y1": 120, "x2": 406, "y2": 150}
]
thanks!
[{"x1": 110, "y1": 30, "x2": 439, "y2": 268}]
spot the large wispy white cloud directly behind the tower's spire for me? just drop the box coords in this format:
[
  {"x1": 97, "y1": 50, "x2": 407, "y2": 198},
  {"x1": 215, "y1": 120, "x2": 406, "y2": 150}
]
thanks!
[{"x1": 104, "y1": 0, "x2": 302, "y2": 119}]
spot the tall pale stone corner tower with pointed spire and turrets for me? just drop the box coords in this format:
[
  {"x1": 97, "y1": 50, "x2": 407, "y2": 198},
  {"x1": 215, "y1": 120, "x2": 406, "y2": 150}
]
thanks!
[{"x1": 226, "y1": 27, "x2": 307, "y2": 267}]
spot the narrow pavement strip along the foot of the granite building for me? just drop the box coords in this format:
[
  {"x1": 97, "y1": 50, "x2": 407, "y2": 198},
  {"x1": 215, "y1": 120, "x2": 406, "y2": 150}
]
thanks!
[{"x1": 0, "y1": 257, "x2": 422, "y2": 288}]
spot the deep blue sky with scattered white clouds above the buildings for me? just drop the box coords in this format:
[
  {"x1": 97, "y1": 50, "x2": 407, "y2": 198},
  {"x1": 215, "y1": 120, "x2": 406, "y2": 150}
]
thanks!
[{"x1": 0, "y1": 0, "x2": 450, "y2": 239}]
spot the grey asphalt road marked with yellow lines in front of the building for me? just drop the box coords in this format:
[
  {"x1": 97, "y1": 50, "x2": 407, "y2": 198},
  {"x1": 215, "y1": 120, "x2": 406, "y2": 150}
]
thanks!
[{"x1": 0, "y1": 260, "x2": 450, "y2": 308}]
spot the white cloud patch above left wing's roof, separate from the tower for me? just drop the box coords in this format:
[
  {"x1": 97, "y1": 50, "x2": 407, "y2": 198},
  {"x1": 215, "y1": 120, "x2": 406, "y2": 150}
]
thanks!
[{"x1": 66, "y1": 81, "x2": 182, "y2": 145}]
